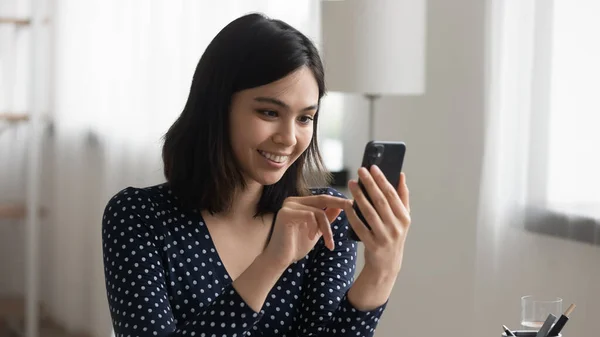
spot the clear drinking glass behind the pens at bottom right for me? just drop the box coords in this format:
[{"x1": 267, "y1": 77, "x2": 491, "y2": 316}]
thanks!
[{"x1": 521, "y1": 295, "x2": 563, "y2": 330}]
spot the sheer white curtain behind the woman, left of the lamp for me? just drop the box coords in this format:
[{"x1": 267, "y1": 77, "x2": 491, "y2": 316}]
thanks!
[{"x1": 41, "y1": 0, "x2": 320, "y2": 336}]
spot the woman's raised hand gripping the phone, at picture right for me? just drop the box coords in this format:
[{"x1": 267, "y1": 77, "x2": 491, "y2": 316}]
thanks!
[{"x1": 346, "y1": 165, "x2": 411, "y2": 279}]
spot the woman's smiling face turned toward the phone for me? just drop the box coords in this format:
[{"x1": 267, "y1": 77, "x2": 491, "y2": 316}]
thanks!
[{"x1": 230, "y1": 67, "x2": 319, "y2": 185}]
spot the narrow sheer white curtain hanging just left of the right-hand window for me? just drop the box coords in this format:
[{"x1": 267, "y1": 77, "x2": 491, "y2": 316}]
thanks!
[{"x1": 478, "y1": 0, "x2": 550, "y2": 252}]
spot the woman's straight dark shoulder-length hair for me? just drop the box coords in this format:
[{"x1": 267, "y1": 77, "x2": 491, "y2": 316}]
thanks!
[{"x1": 162, "y1": 13, "x2": 330, "y2": 215}]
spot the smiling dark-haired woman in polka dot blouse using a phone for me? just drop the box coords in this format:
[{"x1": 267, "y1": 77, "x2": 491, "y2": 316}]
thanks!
[{"x1": 102, "y1": 14, "x2": 410, "y2": 336}]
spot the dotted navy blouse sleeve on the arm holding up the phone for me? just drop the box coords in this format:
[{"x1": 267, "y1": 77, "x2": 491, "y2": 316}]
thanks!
[{"x1": 298, "y1": 188, "x2": 387, "y2": 337}]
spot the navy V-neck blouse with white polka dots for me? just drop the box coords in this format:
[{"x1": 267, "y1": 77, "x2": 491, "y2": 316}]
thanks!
[{"x1": 102, "y1": 184, "x2": 387, "y2": 337}]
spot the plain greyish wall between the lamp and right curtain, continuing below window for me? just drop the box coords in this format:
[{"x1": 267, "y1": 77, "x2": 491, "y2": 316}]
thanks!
[{"x1": 344, "y1": 0, "x2": 600, "y2": 337}]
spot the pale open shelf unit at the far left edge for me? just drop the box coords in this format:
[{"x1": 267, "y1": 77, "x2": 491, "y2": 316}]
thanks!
[{"x1": 0, "y1": 4, "x2": 50, "y2": 337}]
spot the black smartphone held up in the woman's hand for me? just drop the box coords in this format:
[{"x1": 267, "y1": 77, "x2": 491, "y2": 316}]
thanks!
[{"x1": 348, "y1": 140, "x2": 406, "y2": 241}]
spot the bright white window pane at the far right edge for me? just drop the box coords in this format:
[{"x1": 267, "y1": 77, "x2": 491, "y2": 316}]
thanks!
[{"x1": 547, "y1": 0, "x2": 600, "y2": 219}]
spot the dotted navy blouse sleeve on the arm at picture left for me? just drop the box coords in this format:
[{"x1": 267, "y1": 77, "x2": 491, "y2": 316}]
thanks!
[{"x1": 102, "y1": 188, "x2": 262, "y2": 337}]
